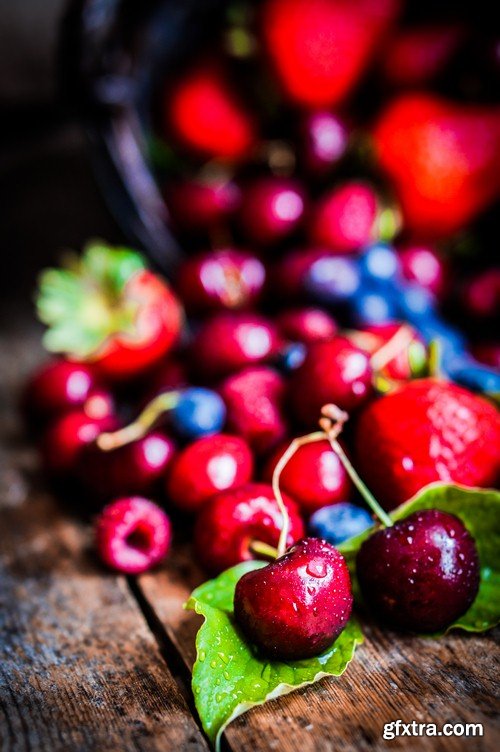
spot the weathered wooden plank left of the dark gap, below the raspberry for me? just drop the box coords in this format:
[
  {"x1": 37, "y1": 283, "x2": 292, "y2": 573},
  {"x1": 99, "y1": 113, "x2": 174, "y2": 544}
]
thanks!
[{"x1": 0, "y1": 328, "x2": 208, "y2": 752}]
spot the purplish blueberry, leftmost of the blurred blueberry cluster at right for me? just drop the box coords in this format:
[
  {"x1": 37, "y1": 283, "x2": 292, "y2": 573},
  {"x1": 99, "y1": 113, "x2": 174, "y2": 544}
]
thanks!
[{"x1": 304, "y1": 256, "x2": 361, "y2": 305}]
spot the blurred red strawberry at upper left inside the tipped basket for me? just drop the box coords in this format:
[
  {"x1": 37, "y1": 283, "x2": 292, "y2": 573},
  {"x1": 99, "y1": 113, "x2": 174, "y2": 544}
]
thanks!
[{"x1": 165, "y1": 65, "x2": 255, "y2": 160}]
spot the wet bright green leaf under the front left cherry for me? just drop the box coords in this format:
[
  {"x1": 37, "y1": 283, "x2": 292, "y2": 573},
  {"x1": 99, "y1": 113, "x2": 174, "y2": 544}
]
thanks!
[{"x1": 186, "y1": 561, "x2": 363, "y2": 749}]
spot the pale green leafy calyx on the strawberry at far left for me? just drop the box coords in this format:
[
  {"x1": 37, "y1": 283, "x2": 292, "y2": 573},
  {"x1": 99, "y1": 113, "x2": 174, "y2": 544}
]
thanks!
[{"x1": 36, "y1": 241, "x2": 147, "y2": 360}]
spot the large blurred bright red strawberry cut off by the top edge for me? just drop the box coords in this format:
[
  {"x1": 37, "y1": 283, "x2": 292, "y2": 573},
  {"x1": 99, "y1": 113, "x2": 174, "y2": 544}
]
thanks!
[{"x1": 263, "y1": 0, "x2": 399, "y2": 107}]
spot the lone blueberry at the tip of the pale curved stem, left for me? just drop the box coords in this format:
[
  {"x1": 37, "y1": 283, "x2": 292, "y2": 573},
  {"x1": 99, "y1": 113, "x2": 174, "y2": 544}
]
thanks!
[{"x1": 170, "y1": 387, "x2": 226, "y2": 439}]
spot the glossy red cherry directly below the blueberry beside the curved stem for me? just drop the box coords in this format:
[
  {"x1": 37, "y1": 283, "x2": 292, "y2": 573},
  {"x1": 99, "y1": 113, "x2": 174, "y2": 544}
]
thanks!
[{"x1": 166, "y1": 433, "x2": 253, "y2": 512}]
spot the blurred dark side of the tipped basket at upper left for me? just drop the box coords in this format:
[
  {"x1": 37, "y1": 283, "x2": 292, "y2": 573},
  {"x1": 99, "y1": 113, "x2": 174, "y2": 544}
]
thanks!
[{"x1": 59, "y1": 0, "x2": 227, "y2": 275}]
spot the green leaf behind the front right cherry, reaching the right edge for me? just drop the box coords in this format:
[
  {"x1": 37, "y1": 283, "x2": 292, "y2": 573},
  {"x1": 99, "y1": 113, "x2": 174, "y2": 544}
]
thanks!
[{"x1": 338, "y1": 483, "x2": 500, "y2": 636}]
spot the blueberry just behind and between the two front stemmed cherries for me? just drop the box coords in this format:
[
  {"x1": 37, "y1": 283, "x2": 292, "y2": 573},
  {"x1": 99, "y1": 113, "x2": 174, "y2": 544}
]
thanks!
[{"x1": 309, "y1": 501, "x2": 373, "y2": 546}]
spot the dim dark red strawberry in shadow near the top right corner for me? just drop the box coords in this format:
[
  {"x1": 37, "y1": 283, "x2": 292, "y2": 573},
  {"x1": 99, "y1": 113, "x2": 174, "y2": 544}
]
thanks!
[{"x1": 382, "y1": 24, "x2": 464, "y2": 86}]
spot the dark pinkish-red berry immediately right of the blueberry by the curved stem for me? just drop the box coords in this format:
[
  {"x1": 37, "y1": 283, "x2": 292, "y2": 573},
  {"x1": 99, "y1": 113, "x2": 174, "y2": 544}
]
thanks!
[{"x1": 220, "y1": 366, "x2": 287, "y2": 455}]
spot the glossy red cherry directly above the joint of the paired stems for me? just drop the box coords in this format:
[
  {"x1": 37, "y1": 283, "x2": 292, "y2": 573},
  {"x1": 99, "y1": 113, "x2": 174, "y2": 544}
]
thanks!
[{"x1": 288, "y1": 337, "x2": 373, "y2": 427}]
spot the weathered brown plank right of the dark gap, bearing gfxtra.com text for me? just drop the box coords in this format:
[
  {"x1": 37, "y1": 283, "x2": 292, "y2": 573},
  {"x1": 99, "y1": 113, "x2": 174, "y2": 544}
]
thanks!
[{"x1": 139, "y1": 547, "x2": 500, "y2": 752}]
